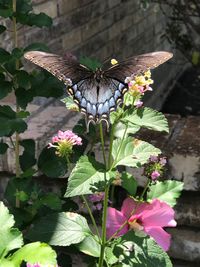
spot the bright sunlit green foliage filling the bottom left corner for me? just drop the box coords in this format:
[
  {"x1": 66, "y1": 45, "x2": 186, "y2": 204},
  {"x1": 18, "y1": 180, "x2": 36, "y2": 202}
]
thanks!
[{"x1": 0, "y1": 202, "x2": 56, "y2": 267}]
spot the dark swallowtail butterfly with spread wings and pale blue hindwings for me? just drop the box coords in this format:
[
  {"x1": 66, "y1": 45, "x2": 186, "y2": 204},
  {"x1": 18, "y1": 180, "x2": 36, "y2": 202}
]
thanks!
[{"x1": 24, "y1": 51, "x2": 173, "y2": 126}]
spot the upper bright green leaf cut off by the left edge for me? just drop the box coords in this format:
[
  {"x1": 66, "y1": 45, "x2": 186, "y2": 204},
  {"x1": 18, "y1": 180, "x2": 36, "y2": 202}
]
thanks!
[{"x1": 0, "y1": 202, "x2": 23, "y2": 258}]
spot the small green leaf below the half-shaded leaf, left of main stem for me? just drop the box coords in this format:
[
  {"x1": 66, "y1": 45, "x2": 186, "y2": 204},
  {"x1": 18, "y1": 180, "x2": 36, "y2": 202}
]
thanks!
[{"x1": 76, "y1": 235, "x2": 101, "y2": 258}]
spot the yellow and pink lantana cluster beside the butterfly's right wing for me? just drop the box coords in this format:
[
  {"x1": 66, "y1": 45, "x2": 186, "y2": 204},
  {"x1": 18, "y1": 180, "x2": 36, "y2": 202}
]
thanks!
[{"x1": 125, "y1": 70, "x2": 153, "y2": 108}]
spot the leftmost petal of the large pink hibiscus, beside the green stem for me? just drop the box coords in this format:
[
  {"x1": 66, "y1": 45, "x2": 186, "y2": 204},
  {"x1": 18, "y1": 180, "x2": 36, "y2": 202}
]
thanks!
[{"x1": 106, "y1": 208, "x2": 128, "y2": 238}]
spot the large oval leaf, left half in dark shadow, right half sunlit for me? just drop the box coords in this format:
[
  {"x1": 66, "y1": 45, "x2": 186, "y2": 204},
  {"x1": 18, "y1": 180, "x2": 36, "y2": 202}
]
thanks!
[{"x1": 27, "y1": 212, "x2": 91, "y2": 246}]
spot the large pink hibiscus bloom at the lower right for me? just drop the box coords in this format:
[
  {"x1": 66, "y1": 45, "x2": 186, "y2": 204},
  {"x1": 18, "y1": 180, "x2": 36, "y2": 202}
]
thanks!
[{"x1": 107, "y1": 198, "x2": 176, "y2": 251}]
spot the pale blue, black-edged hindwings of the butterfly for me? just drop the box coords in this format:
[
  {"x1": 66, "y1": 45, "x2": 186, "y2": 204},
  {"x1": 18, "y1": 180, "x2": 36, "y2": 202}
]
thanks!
[{"x1": 68, "y1": 78, "x2": 127, "y2": 122}]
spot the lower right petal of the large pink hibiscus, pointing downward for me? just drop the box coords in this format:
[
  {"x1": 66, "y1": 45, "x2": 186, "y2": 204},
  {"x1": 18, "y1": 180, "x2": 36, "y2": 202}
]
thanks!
[{"x1": 144, "y1": 227, "x2": 171, "y2": 251}]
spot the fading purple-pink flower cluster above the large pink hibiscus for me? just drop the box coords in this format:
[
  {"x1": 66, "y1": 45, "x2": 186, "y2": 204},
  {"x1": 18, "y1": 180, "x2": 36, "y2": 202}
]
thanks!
[{"x1": 144, "y1": 155, "x2": 167, "y2": 181}]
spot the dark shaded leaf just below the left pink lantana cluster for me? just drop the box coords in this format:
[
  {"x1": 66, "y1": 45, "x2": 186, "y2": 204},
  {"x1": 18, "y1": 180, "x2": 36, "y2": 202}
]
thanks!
[{"x1": 38, "y1": 147, "x2": 67, "y2": 178}]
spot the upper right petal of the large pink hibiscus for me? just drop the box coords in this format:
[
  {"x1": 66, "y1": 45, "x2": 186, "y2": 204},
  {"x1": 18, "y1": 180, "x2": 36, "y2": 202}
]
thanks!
[{"x1": 142, "y1": 199, "x2": 176, "y2": 227}]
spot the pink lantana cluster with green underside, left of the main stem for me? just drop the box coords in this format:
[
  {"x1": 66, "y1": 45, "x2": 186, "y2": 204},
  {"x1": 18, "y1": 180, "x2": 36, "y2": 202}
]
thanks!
[{"x1": 48, "y1": 130, "x2": 82, "y2": 157}]
